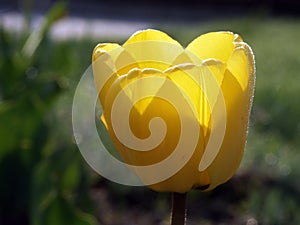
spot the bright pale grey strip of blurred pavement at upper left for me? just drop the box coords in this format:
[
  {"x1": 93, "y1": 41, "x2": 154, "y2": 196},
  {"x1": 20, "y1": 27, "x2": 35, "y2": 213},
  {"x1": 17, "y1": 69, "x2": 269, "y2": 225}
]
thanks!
[{"x1": 0, "y1": 12, "x2": 151, "y2": 40}]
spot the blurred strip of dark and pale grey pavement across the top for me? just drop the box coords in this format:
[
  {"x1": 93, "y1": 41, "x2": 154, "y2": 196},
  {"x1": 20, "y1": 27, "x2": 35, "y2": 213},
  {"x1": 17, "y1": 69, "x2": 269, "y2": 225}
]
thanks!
[{"x1": 0, "y1": 0, "x2": 300, "y2": 40}]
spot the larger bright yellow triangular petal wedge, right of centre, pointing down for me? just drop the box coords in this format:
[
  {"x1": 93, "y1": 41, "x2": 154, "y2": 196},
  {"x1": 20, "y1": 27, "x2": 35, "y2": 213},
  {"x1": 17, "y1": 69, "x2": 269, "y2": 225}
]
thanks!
[{"x1": 165, "y1": 60, "x2": 225, "y2": 136}]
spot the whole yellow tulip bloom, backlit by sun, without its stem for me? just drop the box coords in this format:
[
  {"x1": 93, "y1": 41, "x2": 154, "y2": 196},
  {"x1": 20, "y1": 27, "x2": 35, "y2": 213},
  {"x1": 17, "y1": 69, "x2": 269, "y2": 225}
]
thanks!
[{"x1": 93, "y1": 30, "x2": 255, "y2": 193}]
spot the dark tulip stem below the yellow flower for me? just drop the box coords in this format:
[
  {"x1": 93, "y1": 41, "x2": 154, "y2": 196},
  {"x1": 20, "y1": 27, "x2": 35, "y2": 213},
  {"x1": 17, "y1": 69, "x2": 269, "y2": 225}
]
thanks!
[{"x1": 171, "y1": 192, "x2": 187, "y2": 225}]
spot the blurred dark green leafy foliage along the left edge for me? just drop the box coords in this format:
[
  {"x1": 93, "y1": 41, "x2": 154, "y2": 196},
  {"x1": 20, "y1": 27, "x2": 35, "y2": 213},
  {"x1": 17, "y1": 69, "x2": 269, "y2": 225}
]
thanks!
[{"x1": 0, "y1": 3, "x2": 96, "y2": 225}]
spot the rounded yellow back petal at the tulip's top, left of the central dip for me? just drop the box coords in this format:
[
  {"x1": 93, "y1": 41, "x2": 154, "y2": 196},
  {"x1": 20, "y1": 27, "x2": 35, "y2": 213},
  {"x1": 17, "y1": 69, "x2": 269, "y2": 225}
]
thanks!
[{"x1": 123, "y1": 29, "x2": 184, "y2": 70}]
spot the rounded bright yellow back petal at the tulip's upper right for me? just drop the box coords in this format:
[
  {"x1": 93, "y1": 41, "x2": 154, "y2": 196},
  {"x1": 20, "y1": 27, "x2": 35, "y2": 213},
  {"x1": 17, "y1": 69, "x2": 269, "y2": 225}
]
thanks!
[{"x1": 186, "y1": 32, "x2": 240, "y2": 62}]
